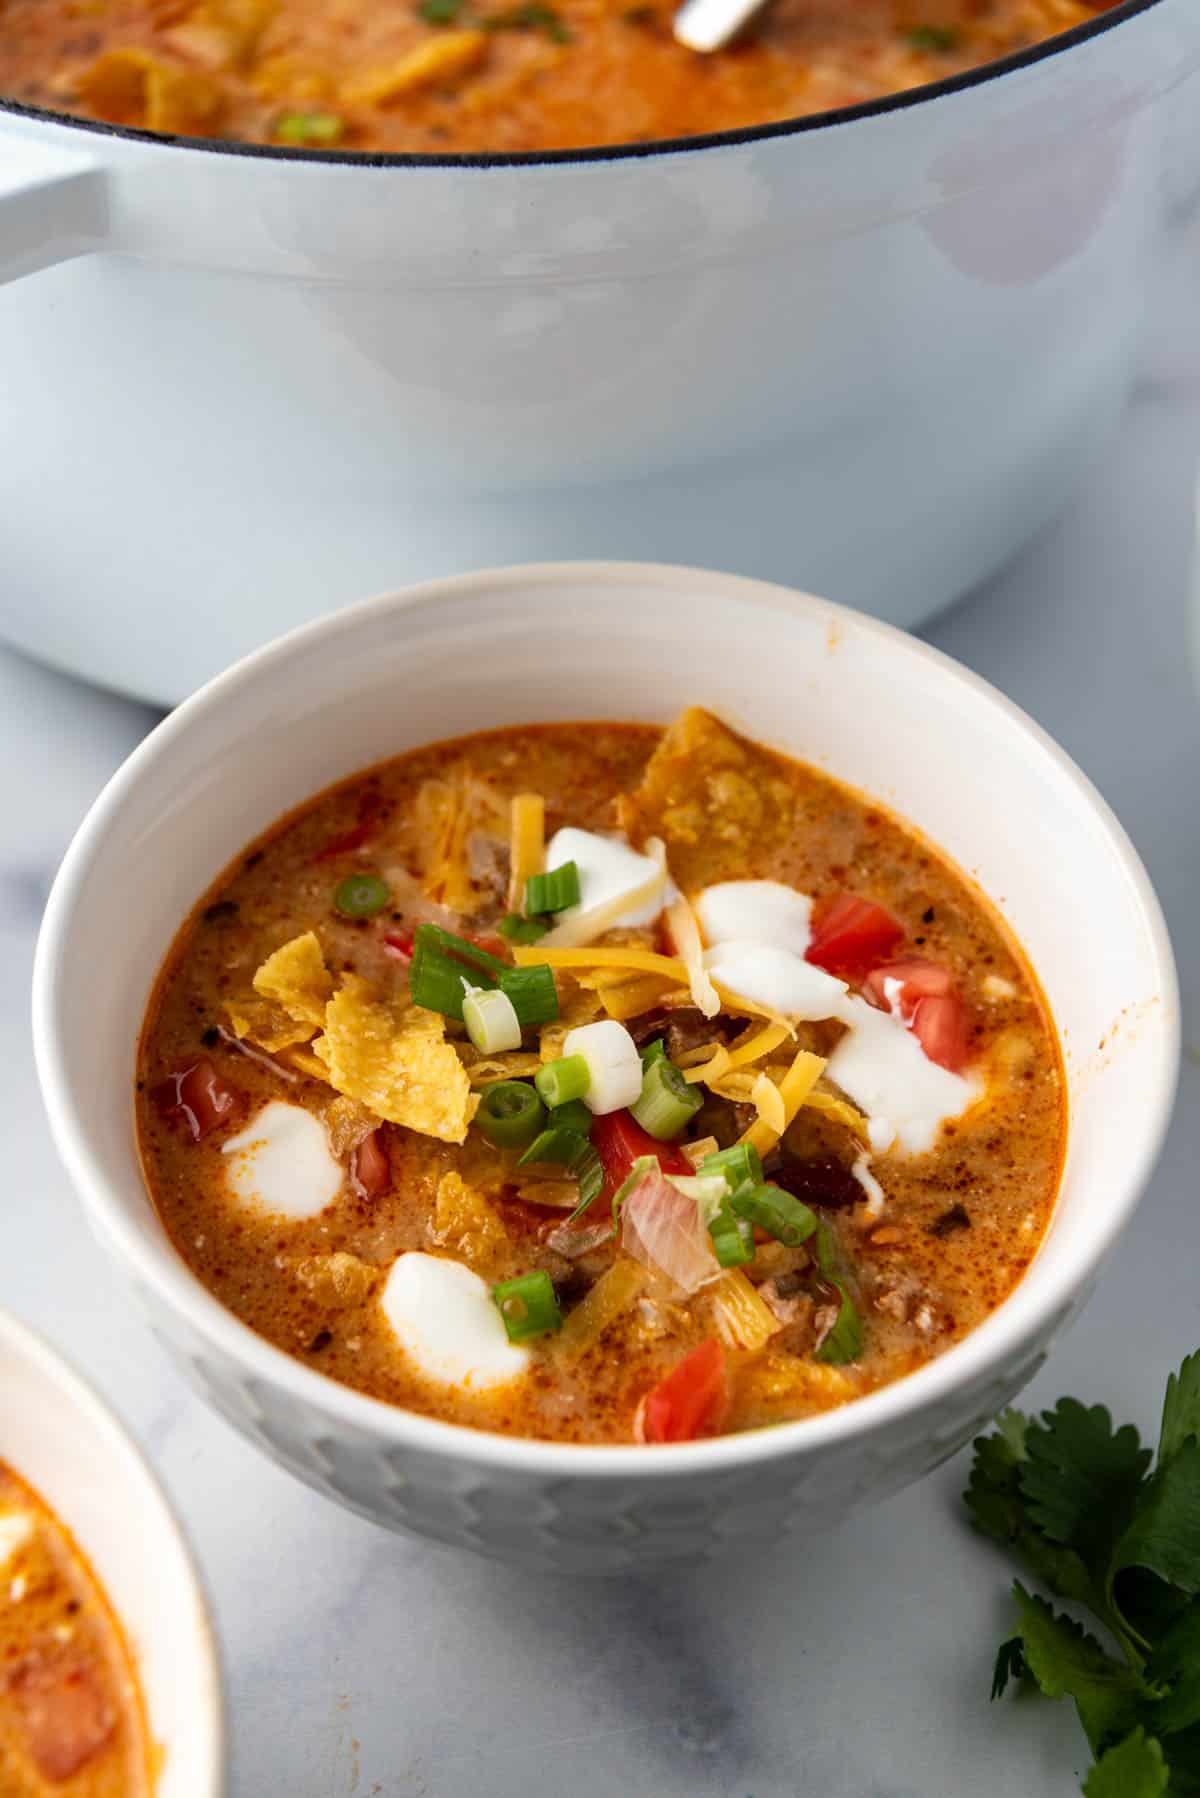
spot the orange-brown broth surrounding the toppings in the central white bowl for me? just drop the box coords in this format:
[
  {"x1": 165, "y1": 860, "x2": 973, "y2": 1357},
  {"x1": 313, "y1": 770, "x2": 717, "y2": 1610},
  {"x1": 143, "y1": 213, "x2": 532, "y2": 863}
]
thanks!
[{"x1": 137, "y1": 714, "x2": 1065, "y2": 1442}]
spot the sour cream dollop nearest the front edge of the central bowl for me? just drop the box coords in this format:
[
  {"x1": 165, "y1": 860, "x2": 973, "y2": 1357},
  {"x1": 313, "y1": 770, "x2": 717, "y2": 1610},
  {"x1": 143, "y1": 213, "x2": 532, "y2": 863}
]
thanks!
[{"x1": 380, "y1": 1250, "x2": 529, "y2": 1392}]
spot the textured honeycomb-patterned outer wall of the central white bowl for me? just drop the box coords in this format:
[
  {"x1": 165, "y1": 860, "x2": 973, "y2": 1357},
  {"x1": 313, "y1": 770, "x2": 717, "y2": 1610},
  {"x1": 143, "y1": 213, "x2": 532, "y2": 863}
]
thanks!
[{"x1": 137, "y1": 1265, "x2": 1087, "y2": 1575}]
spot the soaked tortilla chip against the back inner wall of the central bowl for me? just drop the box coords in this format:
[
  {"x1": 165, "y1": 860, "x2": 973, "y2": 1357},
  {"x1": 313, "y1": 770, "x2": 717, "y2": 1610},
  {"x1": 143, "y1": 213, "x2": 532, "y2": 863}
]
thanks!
[{"x1": 617, "y1": 707, "x2": 795, "y2": 890}]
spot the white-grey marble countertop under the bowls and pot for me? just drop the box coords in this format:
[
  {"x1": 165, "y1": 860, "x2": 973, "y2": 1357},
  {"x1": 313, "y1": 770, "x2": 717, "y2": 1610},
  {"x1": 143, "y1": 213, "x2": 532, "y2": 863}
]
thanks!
[{"x1": 0, "y1": 221, "x2": 1200, "y2": 1798}]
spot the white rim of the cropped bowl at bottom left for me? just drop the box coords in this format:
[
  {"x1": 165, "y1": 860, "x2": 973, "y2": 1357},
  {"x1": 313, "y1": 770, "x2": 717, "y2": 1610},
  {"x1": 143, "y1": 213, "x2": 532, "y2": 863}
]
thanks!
[{"x1": 0, "y1": 1307, "x2": 227, "y2": 1798}]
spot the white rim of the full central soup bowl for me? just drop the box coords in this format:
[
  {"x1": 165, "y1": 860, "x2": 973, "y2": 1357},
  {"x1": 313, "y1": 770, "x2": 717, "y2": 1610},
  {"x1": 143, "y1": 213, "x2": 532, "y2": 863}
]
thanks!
[{"x1": 32, "y1": 561, "x2": 1182, "y2": 1480}]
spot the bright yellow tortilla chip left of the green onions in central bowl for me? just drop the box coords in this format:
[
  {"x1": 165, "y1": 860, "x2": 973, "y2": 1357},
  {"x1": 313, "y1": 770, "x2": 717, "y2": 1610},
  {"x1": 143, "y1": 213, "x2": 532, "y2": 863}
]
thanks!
[{"x1": 313, "y1": 975, "x2": 479, "y2": 1142}]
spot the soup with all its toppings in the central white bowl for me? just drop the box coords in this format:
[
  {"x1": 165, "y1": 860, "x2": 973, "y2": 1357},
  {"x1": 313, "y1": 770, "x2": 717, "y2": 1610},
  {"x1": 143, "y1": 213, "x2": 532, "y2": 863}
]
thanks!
[{"x1": 137, "y1": 710, "x2": 1065, "y2": 1444}]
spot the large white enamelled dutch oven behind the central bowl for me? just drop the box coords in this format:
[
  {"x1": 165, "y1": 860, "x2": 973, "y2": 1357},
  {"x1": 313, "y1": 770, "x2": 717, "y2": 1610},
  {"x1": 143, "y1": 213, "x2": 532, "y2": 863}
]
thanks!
[{"x1": 0, "y1": 0, "x2": 1200, "y2": 699}]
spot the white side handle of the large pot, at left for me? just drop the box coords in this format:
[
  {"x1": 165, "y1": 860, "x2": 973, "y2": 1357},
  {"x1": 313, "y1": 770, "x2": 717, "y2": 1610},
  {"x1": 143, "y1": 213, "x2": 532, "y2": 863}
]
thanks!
[{"x1": 0, "y1": 137, "x2": 108, "y2": 282}]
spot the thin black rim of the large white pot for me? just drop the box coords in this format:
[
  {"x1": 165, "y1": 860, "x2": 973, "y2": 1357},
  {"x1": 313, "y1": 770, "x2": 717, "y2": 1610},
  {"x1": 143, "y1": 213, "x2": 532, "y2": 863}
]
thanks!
[{"x1": 0, "y1": 0, "x2": 1162, "y2": 169}]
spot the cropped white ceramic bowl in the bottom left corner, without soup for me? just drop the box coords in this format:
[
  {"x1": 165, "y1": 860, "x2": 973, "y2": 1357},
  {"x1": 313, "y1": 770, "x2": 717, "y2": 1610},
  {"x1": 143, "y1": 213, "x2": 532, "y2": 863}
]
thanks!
[{"x1": 0, "y1": 1313, "x2": 225, "y2": 1798}]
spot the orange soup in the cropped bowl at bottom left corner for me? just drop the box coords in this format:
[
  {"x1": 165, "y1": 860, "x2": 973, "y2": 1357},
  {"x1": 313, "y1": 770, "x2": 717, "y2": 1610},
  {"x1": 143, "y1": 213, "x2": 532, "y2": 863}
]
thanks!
[{"x1": 0, "y1": 1462, "x2": 153, "y2": 1798}]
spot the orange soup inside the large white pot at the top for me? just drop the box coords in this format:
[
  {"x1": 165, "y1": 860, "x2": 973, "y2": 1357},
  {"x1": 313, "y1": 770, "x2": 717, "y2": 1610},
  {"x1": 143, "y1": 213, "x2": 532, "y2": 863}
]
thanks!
[{"x1": 0, "y1": 0, "x2": 1108, "y2": 153}]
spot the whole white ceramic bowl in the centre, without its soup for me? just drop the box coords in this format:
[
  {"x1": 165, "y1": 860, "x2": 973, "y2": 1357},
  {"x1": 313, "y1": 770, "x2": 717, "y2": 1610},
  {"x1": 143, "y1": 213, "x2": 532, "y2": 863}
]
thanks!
[{"x1": 34, "y1": 563, "x2": 1178, "y2": 1571}]
